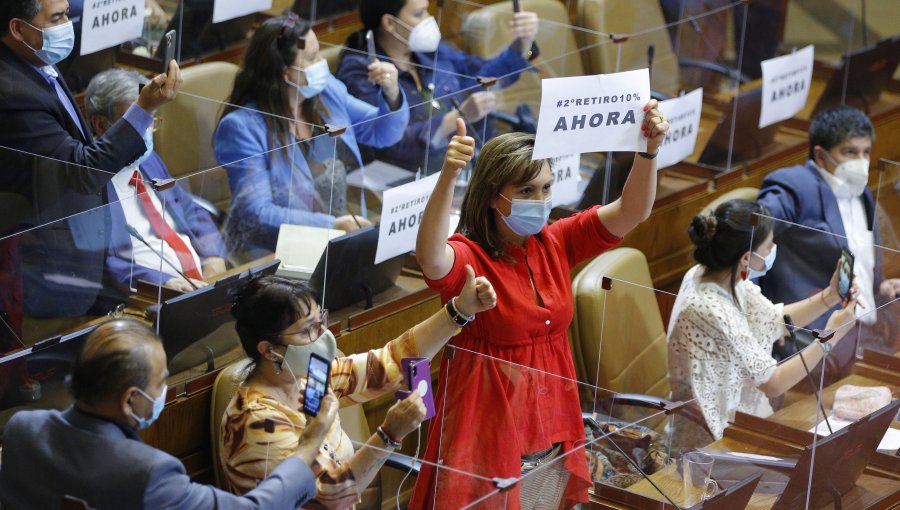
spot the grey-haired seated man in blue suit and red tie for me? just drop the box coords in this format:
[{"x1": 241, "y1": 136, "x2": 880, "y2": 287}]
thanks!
[{"x1": 84, "y1": 69, "x2": 226, "y2": 292}]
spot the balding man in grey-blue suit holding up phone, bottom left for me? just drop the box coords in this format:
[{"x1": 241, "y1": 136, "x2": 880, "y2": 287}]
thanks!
[{"x1": 0, "y1": 319, "x2": 338, "y2": 510}]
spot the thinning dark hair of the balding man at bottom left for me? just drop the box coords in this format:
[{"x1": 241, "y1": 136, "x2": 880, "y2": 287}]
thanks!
[{"x1": 69, "y1": 318, "x2": 162, "y2": 403}]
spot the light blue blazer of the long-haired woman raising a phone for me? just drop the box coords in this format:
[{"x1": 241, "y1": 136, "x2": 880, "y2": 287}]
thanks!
[{"x1": 215, "y1": 77, "x2": 409, "y2": 259}]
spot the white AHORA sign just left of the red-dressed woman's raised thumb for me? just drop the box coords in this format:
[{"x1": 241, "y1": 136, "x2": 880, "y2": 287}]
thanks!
[{"x1": 375, "y1": 173, "x2": 440, "y2": 264}]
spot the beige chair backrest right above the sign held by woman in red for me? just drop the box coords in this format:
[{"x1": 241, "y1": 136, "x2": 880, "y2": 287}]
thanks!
[{"x1": 575, "y1": 0, "x2": 679, "y2": 96}]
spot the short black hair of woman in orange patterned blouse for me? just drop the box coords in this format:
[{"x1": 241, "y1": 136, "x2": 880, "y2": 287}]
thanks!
[{"x1": 231, "y1": 276, "x2": 316, "y2": 363}]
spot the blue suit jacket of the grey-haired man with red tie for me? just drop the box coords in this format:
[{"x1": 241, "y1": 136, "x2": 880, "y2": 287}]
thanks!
[{"x1": 106, "y1": 152, "x2": 228, "y2": 288}]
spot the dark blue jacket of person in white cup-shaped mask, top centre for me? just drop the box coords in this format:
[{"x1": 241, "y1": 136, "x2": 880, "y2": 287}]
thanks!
[{"x1": 337, "y1": 43, "x2": 529, "y2": 171}]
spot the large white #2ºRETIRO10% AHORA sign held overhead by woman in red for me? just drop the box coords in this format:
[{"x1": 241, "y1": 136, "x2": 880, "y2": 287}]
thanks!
[{"x1": 532, "y1": 69, "x2": 650, "y2": 159}]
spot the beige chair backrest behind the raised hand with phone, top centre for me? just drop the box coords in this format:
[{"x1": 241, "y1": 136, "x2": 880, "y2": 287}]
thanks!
[{"x1": 462, "y1": 0, "x2": 584, "y2": 114}]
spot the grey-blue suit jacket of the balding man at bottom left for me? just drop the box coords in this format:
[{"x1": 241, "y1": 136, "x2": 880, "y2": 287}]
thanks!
[{"x1": 0, "y1": 408, "x2": 316, "y2": 510}]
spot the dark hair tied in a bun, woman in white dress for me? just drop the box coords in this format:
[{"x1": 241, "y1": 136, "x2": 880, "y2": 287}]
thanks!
[{"x1": 688, "y1": 199, "x2": 772, "y2": 301}]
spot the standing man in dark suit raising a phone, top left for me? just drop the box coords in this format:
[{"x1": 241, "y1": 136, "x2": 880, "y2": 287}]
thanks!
[{"x1": 0, "y1": 0, "x2": 181, "y2": 334}]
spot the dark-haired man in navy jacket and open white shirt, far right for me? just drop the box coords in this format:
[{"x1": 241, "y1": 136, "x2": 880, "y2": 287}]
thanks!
[{"x1": 757, "y1": 106, "x2": 900, "y2": 366}]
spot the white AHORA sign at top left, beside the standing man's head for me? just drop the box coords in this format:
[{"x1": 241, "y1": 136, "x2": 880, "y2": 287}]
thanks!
[{"x1": 81, "y1": 0, "x2": 144, "y2": 55}]
